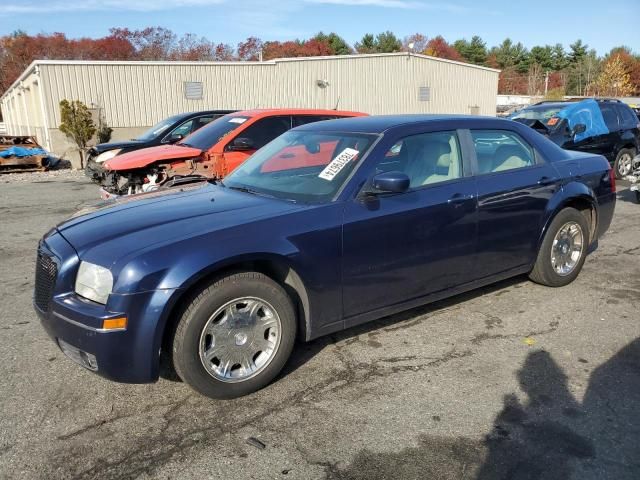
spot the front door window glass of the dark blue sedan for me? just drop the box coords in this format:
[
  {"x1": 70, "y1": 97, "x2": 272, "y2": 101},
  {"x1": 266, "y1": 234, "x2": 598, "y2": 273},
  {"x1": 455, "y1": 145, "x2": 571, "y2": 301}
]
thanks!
[{"x1": 376, "y1": 132, "x2": 462, "y2": 189}]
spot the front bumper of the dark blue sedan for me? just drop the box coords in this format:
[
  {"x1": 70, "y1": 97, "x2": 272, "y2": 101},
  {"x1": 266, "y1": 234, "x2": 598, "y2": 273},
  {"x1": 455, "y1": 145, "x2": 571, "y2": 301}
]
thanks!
[{"x1": 34, "y1": 230, "x2": 177, "y2": 383}]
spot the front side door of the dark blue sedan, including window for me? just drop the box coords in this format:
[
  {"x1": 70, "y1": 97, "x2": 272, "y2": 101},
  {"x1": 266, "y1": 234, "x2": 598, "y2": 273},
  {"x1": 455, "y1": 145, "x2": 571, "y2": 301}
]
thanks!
[{"x1": 343, "y1": 131, "x2": 477, "y2": 326}]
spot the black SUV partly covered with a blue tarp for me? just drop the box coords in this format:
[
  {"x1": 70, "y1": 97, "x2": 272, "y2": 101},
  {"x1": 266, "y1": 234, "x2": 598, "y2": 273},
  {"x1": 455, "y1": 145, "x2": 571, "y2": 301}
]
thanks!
[{"x1": 510, "y1": 99, "x2": 640, "y2": 178}]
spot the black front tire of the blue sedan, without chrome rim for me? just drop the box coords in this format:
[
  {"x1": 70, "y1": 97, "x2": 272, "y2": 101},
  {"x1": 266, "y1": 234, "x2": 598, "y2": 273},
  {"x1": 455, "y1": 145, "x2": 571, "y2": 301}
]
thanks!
[{"x1": 172, "y1": 272, "x2": 297, "y2": 399}]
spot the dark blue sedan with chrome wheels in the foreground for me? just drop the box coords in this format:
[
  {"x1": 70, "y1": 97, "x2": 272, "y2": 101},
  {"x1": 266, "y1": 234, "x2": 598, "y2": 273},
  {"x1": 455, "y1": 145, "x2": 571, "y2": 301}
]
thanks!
[{"x1": 34, "y1": 116, "x2": 615, "y2": 398}]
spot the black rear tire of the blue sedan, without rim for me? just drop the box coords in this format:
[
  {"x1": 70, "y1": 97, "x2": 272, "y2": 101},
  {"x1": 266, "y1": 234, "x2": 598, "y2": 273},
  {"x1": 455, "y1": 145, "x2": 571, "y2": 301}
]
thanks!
[{"x1": 529, "y1": 208, "x2": 590, "y2": 287}]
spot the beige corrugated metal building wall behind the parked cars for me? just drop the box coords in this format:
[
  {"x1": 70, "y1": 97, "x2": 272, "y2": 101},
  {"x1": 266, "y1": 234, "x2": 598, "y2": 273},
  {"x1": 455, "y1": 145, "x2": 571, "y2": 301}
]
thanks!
[{"x1": 1, "y1": 54, "x2": 498, "y2": 166}]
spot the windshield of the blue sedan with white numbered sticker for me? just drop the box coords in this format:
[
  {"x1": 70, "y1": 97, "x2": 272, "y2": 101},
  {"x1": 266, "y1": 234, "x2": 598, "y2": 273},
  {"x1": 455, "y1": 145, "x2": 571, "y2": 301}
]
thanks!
[{"x1": 224, "y1": 130, "x2": 377, "y2": 203}]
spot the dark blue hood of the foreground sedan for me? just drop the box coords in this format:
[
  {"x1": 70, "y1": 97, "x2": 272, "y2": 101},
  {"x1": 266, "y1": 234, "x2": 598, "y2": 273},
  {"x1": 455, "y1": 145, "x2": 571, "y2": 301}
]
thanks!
[{"x1": 57, "y1": 182, "x2": 304, "y2": 263}]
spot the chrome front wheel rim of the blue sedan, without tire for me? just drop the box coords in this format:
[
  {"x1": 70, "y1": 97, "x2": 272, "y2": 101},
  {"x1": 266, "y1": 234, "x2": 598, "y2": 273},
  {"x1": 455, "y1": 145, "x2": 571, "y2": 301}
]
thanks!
[{"x1": 199, "y1": 297, "x2": 282, "y2": 382}]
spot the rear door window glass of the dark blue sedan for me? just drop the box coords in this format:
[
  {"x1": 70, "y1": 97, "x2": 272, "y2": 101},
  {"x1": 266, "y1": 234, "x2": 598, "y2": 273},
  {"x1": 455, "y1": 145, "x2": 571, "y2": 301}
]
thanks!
[{"x1": 471, "y1": 130, "x2": 536, "y2": 174}]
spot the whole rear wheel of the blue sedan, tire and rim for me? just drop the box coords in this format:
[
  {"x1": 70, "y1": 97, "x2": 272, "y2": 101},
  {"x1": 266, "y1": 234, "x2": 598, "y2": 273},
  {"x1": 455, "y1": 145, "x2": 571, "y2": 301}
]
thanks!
[{"x1": 529, "y1": 208, "x2": 589, "y2": 287}]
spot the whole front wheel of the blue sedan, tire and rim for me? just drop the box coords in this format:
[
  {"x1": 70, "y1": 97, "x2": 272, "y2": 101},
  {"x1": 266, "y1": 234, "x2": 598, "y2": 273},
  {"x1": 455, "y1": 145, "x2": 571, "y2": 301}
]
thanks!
[{"x1": 172, "y1": 272, "x2": 296, "y2": 398}]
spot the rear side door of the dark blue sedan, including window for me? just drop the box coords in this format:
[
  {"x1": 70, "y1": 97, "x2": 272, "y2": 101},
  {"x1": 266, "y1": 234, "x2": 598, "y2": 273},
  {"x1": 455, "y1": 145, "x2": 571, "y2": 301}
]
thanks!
[{"x1": 471, "y1": 129, "x2": 560, "y2": 279}]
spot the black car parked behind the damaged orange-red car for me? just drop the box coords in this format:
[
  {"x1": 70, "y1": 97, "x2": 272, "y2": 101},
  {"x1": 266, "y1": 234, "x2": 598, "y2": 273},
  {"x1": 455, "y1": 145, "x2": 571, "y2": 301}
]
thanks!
[{"x1": 85, "y1": 110, "x2": 234, "y2": 183}]
